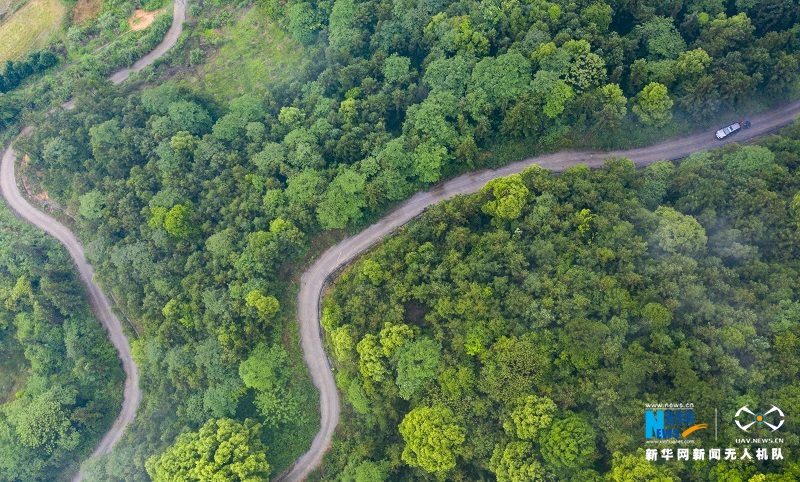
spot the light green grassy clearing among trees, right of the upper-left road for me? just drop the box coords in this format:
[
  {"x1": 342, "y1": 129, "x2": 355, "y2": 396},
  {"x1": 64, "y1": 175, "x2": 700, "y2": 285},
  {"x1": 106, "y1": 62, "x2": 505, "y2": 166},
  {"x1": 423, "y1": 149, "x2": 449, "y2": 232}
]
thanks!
[{"x1": 198, "y1": 8, "x2": 304, "y2": 99}]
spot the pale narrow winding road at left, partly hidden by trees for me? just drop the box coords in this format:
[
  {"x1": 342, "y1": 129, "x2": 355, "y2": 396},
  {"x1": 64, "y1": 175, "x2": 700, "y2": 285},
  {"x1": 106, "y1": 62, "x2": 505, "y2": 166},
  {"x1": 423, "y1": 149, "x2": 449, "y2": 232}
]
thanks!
[{"x1": 0, "y1": 0, "x2": 186, "y2": 482}]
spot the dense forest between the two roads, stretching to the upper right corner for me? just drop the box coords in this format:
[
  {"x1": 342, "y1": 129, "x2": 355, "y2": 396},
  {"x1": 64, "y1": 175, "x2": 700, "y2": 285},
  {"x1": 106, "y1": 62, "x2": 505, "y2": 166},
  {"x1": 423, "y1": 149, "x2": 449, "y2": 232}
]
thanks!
[{"x1": 0, "y1": 0, "x2": 800, "y2": 482}]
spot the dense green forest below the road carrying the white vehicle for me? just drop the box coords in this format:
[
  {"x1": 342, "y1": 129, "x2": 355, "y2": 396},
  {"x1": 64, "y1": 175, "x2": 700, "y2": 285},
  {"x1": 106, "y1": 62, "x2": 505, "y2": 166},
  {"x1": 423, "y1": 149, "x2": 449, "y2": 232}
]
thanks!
[{"x1": 320, "y1": 126, "x2": 800, "y2": 482}]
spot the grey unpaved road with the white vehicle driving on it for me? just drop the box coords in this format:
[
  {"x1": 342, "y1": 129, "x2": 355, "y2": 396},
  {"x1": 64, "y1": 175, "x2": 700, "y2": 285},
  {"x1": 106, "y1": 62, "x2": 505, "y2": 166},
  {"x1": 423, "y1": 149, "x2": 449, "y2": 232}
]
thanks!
[{"x1": 276, "y1": 101, "x2": 800, "y2": 482}]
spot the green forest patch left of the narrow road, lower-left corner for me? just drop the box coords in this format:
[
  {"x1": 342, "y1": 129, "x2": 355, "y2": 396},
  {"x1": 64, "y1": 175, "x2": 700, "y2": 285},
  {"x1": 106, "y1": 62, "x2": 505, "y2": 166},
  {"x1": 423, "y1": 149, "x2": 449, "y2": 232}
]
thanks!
[{"x1": 0, "y1": 209, "x2": 122, "y2": 482}]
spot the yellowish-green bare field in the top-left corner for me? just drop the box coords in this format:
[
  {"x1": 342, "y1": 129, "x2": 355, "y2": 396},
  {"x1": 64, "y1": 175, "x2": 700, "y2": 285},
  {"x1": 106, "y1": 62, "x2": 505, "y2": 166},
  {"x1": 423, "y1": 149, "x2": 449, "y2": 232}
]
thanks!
[{"x1": 0, "y1": 0, "x2": 67, "y2": 63}]
